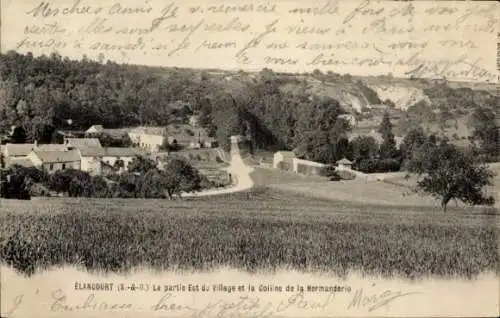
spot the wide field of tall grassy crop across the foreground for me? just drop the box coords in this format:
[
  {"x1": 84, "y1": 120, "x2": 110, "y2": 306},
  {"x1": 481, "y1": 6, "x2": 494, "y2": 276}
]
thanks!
[{"x1": 0, "y1": 188, "x2": 499, "y2": 279}]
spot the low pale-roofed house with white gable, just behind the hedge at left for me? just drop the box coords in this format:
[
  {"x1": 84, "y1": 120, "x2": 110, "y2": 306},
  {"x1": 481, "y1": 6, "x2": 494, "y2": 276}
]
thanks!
[{"x1": 28, "y1": 150, "x2": 81, "y2": 172}]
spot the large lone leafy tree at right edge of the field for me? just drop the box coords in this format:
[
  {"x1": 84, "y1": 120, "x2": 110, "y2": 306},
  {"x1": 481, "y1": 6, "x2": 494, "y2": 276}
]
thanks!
[{"x1": 408, "y1": 142, "x2": 494, "y2": 212}]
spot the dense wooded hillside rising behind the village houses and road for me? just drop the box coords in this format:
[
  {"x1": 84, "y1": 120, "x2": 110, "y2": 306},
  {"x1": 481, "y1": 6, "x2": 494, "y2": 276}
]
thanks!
[{"x1": 0, "y1": 52, "x2": 347, "y2": 161}]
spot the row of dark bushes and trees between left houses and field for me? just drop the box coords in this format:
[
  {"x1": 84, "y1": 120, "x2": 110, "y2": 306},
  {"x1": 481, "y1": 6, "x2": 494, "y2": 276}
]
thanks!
[{"x1": 0, "y1": 156, "x2": 215, "y2": 199}]
